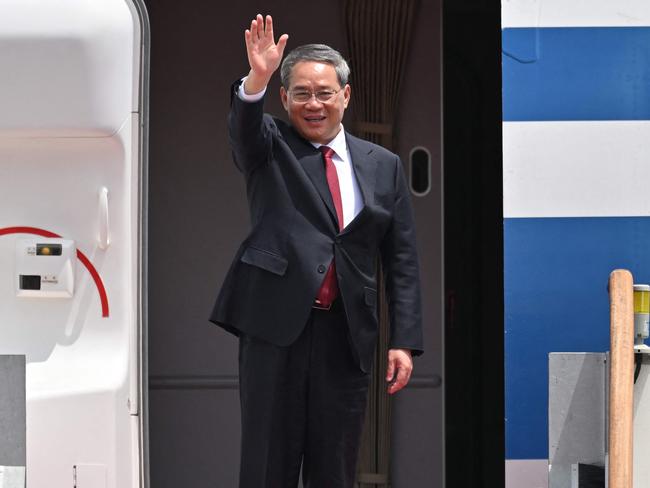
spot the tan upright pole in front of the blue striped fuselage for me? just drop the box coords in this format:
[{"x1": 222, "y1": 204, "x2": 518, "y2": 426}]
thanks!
[{"x1": 608, "y1": 269, "x2": 634, "y2": 488}]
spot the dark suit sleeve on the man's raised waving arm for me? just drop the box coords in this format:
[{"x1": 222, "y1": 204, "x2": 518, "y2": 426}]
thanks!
[{"x1": 228, "y1": 80, "x2": 272, "y2": 175}]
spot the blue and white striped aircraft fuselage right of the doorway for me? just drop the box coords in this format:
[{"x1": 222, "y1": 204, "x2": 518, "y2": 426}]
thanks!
[{"x1": 502, "y1": 0, "x2": 650, "y2": 488}]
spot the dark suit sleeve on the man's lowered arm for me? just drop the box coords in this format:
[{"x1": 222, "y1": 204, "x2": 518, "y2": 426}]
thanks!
[{"x1": 380, "y1": 158, "x2": 423, "y2": 356}]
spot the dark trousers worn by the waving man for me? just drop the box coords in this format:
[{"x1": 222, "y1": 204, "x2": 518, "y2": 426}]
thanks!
[{"x1": 239, "y1": 300, "x2": 370, "y2": 488}]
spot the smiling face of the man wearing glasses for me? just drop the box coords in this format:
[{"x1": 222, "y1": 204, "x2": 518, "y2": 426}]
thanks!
[{"x1": 280, "y1": 61, "x2": 350, "y2": 144}]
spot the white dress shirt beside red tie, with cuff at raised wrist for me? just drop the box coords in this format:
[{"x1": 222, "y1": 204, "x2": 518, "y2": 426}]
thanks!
[{"x1": 238, "y1": 77, "x2": 363, "y2": 227}]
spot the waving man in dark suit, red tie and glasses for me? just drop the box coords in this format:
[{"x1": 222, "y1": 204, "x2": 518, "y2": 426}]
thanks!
[{"x1": 211, "y1": 15, "x2": 422, "y2": 488}]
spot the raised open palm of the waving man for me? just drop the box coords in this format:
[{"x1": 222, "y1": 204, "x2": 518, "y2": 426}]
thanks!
[{"x1": 244, "y1": 14, "x2": 289, "y2": 78}]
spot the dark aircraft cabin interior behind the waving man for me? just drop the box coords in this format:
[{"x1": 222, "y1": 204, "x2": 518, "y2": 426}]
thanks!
[{"x1": 146, "y1": 0, "x2": 505, "y2": 488}]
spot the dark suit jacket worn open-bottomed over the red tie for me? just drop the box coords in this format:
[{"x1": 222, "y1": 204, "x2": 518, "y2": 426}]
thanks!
[{"x1": 210, "y1": 83, "x2": 422, "y2": 371}]
